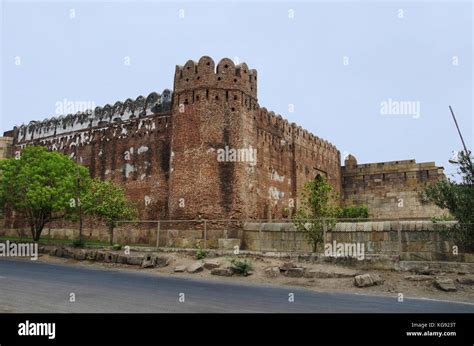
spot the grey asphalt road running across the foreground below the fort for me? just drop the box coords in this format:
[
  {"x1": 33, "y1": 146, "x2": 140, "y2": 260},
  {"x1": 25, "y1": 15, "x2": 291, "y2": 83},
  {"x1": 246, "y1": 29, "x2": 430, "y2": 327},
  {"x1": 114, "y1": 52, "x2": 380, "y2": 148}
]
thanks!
[{"x1": 0, "y1": 258, "x2": 474, "y2": 313}]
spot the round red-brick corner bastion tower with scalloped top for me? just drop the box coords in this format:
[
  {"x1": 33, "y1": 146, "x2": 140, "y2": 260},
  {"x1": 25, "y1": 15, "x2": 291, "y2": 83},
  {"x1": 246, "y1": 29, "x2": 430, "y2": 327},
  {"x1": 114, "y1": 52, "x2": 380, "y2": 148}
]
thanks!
[{"x1": 169, "y1": 56, "x2": 258, "y2": 219}]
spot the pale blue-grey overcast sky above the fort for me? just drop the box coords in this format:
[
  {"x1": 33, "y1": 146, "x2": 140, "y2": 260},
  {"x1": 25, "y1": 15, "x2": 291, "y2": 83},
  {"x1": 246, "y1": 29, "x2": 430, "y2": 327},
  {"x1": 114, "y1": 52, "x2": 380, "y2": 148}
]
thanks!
[{"x1": 0, "y1": 1, "x2": 474, "y2": 178}]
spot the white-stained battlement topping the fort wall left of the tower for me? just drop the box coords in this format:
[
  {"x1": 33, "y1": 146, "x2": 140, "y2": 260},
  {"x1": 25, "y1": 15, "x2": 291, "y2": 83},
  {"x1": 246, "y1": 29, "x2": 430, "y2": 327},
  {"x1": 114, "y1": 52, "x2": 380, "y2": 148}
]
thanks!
[{"x1": 10, "y1": 89, "x2": 172, "y2": 143}]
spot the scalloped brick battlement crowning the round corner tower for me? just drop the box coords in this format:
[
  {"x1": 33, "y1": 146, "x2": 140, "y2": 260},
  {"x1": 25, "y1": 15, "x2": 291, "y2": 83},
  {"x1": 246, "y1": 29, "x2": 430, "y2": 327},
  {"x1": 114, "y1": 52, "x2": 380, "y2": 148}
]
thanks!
[{"x1": 174, "y1": 56, "x2": 257, "y2": 99}]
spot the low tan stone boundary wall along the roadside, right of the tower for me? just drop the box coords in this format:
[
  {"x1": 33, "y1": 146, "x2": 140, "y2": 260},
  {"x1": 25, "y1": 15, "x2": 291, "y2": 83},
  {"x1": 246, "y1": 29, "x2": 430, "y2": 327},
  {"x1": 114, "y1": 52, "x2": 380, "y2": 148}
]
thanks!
[{"x1": 242, "y1": 221, "x2": 472, "y2": 261}]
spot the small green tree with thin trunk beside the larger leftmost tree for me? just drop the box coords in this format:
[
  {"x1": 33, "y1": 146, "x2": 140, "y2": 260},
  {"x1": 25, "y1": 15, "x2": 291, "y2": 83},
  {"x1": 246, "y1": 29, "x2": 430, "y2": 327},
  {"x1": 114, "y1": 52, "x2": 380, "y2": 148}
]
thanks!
[{"x1": 82, "y1": 179, "x2": 137, "y2": 245}]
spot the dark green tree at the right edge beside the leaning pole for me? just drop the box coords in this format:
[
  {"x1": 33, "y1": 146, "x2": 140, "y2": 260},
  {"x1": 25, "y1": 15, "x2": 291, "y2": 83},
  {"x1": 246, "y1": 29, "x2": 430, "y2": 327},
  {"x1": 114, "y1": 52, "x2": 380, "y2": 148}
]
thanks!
[{"x1": 420, "y1": 151, "x2": 474, "y2": 251}]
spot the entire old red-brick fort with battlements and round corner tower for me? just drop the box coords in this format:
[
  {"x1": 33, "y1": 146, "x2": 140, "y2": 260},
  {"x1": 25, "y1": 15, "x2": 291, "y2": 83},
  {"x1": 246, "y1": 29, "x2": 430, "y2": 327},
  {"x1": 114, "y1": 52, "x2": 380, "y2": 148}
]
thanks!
[{"x1": 0, "y1": 56, "x2": 444, "y2": 235}]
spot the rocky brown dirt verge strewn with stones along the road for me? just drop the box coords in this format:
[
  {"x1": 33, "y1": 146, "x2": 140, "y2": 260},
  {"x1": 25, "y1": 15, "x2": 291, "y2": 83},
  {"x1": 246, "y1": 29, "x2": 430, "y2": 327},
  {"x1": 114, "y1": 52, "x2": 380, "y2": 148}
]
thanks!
[{"x1": 38, "y1": 252, "x2": 474, "y2": 303}]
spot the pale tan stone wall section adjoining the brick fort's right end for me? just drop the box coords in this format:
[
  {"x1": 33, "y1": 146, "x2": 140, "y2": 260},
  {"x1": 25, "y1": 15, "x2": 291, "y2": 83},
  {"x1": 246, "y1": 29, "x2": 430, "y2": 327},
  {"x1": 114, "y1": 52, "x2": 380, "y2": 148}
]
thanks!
[{"x1": 342, "y1": 155, "x2": 448, "y2": 218}]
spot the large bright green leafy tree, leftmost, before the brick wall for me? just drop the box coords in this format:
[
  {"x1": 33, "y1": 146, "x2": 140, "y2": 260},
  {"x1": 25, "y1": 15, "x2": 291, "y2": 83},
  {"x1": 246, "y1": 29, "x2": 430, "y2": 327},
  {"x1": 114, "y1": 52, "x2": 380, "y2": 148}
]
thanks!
[{"x1": 0, "y1": 146, "x2": 90, "y2": 241}]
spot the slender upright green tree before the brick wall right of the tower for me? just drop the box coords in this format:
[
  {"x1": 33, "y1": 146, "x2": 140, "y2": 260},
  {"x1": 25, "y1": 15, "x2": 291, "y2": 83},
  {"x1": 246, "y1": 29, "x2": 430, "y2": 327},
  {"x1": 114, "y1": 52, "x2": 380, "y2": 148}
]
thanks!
[{"x1": 293, "y1": 175, "x2": 339, "y2": 252}]
